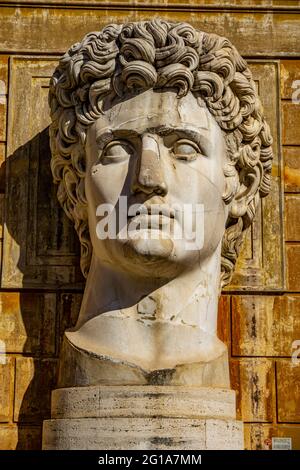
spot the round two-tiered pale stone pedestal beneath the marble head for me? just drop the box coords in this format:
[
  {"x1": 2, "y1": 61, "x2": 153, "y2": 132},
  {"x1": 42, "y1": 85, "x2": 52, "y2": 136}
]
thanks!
[{"x1": 43, "y1": 385, "x2": 244, "y2": 450}]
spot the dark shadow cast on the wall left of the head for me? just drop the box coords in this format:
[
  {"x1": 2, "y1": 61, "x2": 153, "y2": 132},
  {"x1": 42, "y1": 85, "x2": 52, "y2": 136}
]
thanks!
[{"x1": 0, "y1": 128, "x2": 84, "y2": 449}]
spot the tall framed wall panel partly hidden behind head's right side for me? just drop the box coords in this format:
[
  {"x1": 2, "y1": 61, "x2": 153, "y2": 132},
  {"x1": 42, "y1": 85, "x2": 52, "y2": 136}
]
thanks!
[{"x1": 225, "y1": 61, "x2": 284, "y2": 291}]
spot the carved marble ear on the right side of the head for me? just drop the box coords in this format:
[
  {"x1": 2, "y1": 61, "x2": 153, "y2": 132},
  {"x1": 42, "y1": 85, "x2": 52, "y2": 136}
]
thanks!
[{"x1": 229, "y1": 146, "x2": 263, "y2": 226}]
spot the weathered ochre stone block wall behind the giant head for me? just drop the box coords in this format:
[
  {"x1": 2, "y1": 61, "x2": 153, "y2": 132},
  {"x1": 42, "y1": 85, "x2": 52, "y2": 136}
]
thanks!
[{"x1": 0, "y1": 0, "x2": 300, "y2": 449}]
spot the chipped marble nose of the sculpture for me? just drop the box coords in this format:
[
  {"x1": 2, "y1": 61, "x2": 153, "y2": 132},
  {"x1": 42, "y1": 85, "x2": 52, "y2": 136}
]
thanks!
[{"x1": 132, "y1": 134, "x2": 168, "y2": 196}]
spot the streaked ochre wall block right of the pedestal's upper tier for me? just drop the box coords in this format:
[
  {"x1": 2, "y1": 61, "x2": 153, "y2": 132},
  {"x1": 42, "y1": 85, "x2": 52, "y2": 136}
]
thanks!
[{"x1": 230, "y1": 359, "x2": 274, "y2": 422}]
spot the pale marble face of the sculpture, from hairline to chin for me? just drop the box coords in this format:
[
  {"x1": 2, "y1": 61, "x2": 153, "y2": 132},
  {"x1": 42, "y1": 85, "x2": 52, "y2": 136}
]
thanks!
[{"x1": 85, "y1": 90, "x2": 228, "y2": 277}]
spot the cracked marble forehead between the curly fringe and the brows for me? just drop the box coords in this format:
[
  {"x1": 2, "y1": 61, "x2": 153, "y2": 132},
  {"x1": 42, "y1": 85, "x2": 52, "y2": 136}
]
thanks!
[{"x1": 97, "y1": 90, "x2": 210, "y2": 132}]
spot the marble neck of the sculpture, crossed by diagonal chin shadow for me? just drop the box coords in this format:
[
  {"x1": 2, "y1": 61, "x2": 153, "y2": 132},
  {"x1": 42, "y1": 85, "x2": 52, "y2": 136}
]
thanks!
[{"x1": 77, "y1": 247, "x2": 220, "y2": 334}]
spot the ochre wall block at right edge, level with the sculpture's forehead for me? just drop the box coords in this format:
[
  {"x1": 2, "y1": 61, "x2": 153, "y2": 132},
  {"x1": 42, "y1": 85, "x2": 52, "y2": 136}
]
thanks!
[{"x1": 281, "y1": 101, "x2": 300, "y2": 145}]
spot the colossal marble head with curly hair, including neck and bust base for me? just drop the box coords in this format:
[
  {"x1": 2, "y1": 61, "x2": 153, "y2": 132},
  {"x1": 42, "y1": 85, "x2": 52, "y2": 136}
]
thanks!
[{"x1": 49, "y1": 19, "x2": 272, "y2": 387}]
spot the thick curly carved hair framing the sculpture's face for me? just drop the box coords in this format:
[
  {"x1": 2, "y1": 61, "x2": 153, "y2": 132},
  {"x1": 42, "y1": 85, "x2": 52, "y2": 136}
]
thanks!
[{"x1": 49, "y1": 19, "x2": 272, "y2": 286}]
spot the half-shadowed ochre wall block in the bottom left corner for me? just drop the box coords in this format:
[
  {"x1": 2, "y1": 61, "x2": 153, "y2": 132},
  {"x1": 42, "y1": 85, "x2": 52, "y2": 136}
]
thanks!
[{"x1": 0, "y1": 424, "x2": 41, "y2": 450}]
